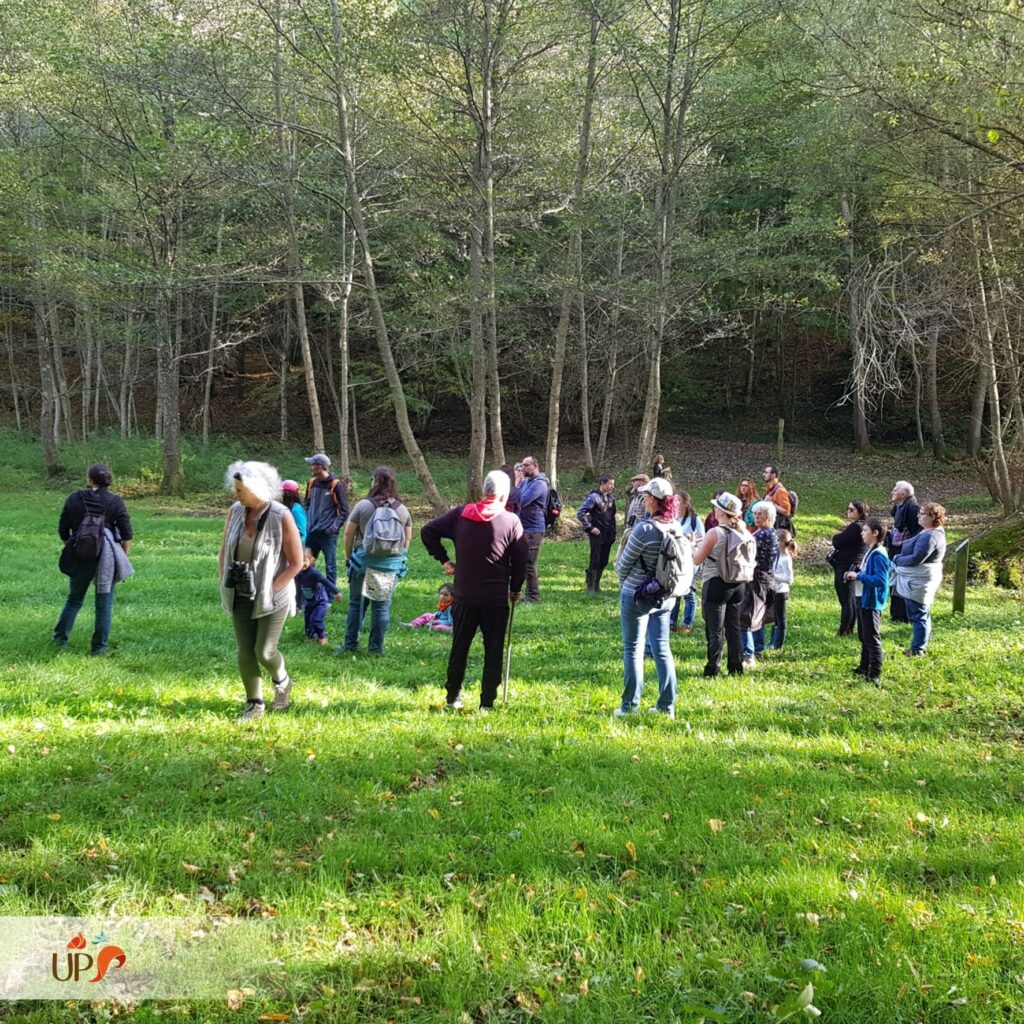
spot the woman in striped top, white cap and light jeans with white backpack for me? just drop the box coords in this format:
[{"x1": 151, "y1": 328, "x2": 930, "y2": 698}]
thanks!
[{"x1": 612, "y1": 476, "x2": 685, "y2": 718}]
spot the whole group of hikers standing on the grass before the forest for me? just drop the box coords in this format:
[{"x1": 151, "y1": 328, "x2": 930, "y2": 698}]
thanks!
[{"x1": 53, "y1": 453, "x2": 945, "y2": 720}]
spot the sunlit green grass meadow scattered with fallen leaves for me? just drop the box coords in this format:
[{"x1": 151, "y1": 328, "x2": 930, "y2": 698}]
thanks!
[{"x1": 0, "y1": 437, "x2": 1024, "y2": 1024}]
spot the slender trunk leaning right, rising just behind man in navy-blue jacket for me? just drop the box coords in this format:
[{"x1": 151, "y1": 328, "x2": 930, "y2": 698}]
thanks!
[{"x1": 544, "y1": 6, "x2": 601, "y2": 487}]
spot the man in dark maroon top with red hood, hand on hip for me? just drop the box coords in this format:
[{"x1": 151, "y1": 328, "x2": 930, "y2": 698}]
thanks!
[{"x1": 420, "y1": 469, "x2": 527, "y2": 714}]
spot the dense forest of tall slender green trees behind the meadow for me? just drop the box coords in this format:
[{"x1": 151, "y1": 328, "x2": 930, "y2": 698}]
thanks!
[{"x1": 0, "y1": 0, "x2": 1024, "y2": 513}]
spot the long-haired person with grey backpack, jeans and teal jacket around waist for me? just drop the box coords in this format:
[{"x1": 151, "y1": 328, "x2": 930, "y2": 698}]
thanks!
[{"x1": 342, "y1": 466, "x2": 413, "y2": 654}]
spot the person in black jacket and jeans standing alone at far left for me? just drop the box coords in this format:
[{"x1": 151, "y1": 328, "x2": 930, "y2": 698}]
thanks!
[{"x1": 53, "y1": 462, "x2": 132, "y2": 655}]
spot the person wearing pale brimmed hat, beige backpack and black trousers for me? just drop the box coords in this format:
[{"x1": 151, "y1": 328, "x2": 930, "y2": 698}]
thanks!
[{"x1": 693, "y1": 490, "x2": 757, "y2": 678}]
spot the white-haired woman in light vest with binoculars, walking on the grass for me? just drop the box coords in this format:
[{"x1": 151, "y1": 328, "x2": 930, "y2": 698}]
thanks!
[{"x1": 218, "y1": 462, "x2": 302, "y2": 721}]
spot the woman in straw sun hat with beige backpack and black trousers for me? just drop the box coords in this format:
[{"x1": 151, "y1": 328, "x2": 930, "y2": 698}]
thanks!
[{"x1": 693, "y1": 490, "x2": 750, "y2": 678}]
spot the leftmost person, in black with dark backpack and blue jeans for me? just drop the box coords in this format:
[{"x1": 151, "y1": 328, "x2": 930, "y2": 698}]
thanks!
[{"x1": 53, "y1": 463, "x2": 132, "y2": 656}]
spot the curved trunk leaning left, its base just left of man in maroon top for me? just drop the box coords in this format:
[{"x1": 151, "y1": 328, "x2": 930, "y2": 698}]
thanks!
[{"x1": 330, "y1": 0, "x2": 447, "y2": 513}]
